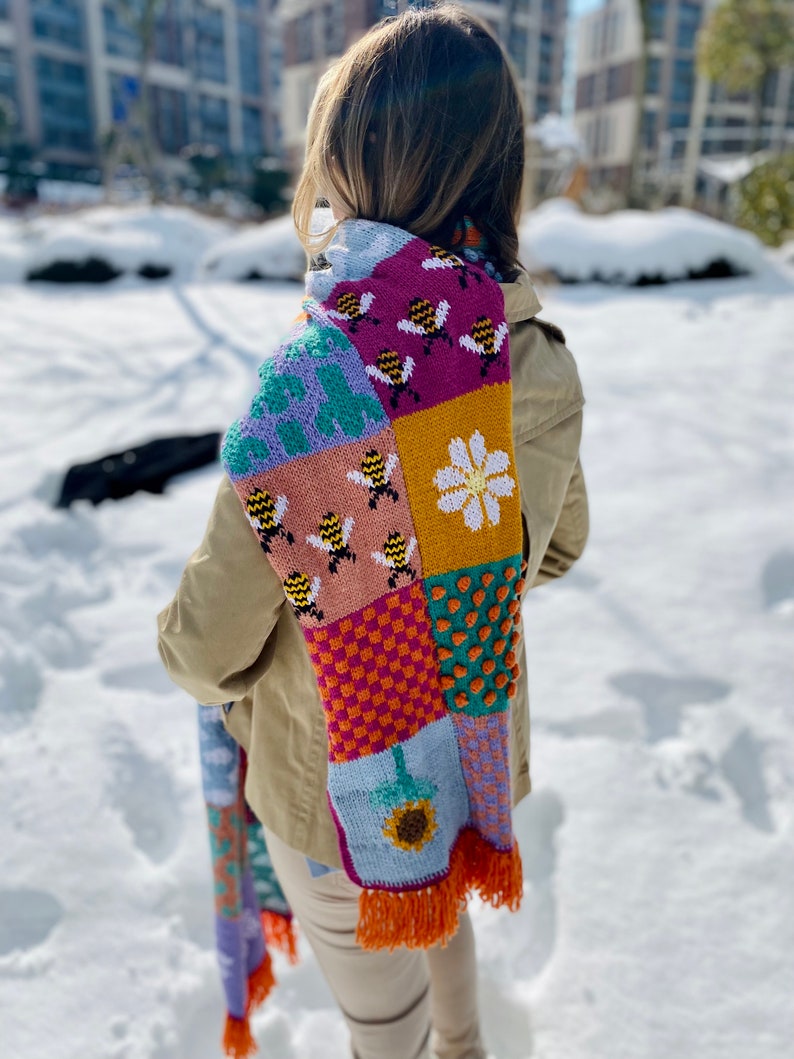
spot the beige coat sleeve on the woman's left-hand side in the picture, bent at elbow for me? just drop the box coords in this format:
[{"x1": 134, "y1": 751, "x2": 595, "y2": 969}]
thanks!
[{"x1": 158, "y1": 477, "x2": 286, "y2": 705}]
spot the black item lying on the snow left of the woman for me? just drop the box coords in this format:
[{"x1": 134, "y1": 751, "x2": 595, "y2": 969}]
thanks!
[{"x1": 55, "y1": 432, "x2": 221, "y2": 507}]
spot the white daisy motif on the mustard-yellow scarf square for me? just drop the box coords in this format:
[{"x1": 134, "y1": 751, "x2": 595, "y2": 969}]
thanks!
[{"x1": 433, "y1": 430, "x2": 516, "y2": 532}]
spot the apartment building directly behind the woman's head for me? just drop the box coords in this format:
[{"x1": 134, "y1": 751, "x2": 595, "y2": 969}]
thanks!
[{"x1": 277, "y1": 0, "x2": 567, "y2": 166}]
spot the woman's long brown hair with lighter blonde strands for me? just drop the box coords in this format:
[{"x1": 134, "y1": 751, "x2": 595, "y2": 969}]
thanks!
[{"x1": 292, "y1": 3, "x2": 524, "y2": 271}]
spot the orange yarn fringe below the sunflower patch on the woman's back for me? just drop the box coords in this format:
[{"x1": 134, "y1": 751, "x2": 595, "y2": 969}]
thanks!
[{"x1": 356, "y1": 828, "x2": 524, "y2": 950}]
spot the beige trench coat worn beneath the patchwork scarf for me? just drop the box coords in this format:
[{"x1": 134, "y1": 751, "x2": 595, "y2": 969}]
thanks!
[{"x1": 158, "y1": 274, "x2": 588, "y2": 867}]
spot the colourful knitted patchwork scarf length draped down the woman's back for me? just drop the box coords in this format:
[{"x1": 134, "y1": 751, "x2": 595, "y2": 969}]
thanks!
[{"x1": 221, "y1": 220, "x2": 524, "y2": 949}]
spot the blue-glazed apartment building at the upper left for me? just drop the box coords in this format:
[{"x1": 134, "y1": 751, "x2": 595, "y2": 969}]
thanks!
[{"x1": 0, "y1": 0, "x2": 282, "y2": 173}]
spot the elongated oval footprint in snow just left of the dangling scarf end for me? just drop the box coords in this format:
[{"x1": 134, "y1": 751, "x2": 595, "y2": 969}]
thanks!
[{"x1": 108, "y1": 736, "x2": 182, "y2": 864}]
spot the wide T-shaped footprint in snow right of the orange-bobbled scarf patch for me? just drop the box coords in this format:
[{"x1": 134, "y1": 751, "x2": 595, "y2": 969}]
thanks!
[{"x1": 610, "y1": 670, "x2": 732, "y2": 742}]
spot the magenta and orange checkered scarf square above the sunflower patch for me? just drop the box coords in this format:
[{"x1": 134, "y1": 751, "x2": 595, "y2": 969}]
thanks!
[{"x1": 304, "y1": 581, "x2": 447, "y2": 762}]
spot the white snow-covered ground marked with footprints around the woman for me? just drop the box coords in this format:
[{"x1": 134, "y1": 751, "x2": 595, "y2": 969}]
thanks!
[{"x1": 0, "y1": 208, "x2": 794, "y2": 1059}]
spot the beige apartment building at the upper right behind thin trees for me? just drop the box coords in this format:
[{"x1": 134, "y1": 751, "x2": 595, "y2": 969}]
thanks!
[{"x1": 575, "y1": 0, "x2": 794, "y2": 191}]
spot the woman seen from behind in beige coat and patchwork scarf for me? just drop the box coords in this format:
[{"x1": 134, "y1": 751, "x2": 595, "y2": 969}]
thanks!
[{"x1": 160, "y1": 4, "x2": 588, "y2": 1059}]
